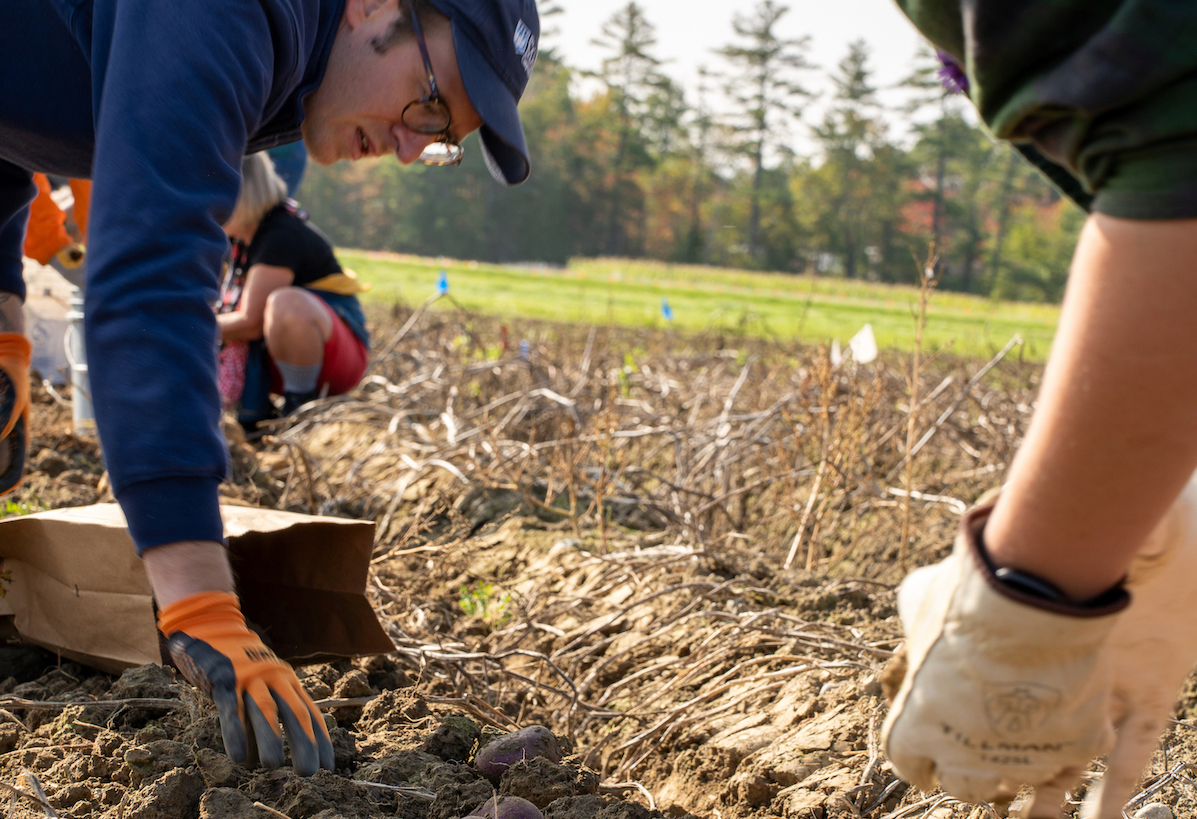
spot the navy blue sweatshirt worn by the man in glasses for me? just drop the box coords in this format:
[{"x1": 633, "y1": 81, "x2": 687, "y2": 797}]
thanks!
[{"x1": 0, "y1": 0, "x2": 345, "y2": 551}]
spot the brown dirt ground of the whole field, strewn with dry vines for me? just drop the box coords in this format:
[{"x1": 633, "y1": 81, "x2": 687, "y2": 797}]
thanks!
[{"x1": 0, "y1": 307, "x2": 1197, "y2": 819}]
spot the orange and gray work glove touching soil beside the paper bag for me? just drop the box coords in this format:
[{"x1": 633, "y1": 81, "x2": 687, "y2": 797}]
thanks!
[{"x1": 158, "y1": 592, "x2": 334, "y2": 776}]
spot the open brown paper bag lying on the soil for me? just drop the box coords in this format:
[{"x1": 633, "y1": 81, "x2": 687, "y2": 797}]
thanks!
[{"x1": 0, "y1": 503, "x2": 394, "y2": 673}]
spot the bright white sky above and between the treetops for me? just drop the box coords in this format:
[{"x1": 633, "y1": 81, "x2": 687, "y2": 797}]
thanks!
[{"x1": 545, "y1": 0, "x2": 920, "y2": 143}]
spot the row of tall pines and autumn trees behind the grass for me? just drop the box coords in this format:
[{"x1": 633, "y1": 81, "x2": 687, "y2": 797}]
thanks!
[{"x1": 302, "y1": 0, "x2": 1083, "y2": 301}]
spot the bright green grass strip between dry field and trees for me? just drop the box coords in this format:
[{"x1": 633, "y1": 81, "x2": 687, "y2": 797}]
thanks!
[{"x1": 338, "y1": 250, "x2": 1059, "y2": 360}]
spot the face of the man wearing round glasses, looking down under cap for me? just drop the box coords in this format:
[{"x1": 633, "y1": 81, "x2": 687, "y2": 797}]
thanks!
[{"x1": 303, "y1": 0, "x2": 482, "y2": 165}]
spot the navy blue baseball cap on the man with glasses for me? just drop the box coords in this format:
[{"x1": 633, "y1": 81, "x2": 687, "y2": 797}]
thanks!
[{"x1": 429, "y1": 0, "x2": 540, "y2": 184}]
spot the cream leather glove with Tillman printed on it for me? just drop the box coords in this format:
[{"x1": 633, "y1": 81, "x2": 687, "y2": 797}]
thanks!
[{"x1": 882, "y1": 506, "x2": 1129, "y2": 809}]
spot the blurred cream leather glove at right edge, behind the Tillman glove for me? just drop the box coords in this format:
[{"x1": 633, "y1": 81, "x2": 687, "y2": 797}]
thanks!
[{"x1": 1072, "y1": 480, "x2": 1197, "y2": 819}]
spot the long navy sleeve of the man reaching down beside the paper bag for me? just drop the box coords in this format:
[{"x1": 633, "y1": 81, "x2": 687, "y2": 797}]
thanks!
[{"x1": 85, "y1": 0, "x2": 273, "y2": 552}]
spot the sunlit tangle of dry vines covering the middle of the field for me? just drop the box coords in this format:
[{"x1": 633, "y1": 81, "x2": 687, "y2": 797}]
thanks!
[{"x1": 205, "y1": 305, "x2": 1038, "y2": 815}]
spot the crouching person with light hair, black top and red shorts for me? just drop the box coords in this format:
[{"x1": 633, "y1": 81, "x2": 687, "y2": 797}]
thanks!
[{"x1": 217, "y1": 153, "x2": 370, "y2": 430}]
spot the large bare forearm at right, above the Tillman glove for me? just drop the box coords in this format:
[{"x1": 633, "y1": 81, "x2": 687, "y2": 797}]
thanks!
[{"x1": 985, "y1": 214, "x2": 1197, "y2": 600}]
